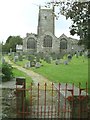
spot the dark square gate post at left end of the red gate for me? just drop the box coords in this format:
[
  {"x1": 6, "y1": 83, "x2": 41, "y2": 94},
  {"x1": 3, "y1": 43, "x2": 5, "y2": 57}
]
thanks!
[{"x1": 16, "y1": 77, "x2": 26, "y2": 118}]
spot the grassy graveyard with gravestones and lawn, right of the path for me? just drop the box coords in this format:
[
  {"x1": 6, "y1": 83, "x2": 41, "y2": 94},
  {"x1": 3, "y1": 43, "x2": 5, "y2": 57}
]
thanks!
[{"x1": 6, "y1": 52, "x2": 88, "y2": 87}]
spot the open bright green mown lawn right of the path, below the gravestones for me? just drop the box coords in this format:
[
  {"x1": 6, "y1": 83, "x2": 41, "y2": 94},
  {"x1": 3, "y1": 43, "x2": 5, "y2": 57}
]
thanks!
[{"x1": 32, "y1": 56, "x2": 88, "y2": 87}]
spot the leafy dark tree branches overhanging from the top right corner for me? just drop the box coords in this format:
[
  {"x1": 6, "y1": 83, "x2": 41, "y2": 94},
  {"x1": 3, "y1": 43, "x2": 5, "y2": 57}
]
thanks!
[{"x1": 47, "y1": 0, "x2": 90, "y2": 48}]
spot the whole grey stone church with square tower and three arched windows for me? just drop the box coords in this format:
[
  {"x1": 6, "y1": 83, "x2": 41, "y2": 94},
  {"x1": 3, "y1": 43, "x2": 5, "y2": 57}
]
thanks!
[{"x1": 23, "y1": 7, "x2": 82, "y2": 53}]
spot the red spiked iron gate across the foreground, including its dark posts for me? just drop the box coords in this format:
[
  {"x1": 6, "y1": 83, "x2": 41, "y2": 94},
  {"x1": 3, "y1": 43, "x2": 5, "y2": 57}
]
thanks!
[{"x1": 16, "y1": 81, "x2": 88, "y2": 119}]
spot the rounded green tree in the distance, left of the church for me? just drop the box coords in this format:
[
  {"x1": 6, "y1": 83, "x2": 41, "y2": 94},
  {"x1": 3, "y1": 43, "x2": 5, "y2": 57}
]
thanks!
[{"x1": 2, "y1": 36, "x2": 23, "y2": 52}]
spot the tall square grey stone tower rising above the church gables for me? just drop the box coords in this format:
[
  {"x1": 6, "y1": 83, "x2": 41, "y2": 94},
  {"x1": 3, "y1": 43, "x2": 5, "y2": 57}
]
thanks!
[{"x1": 37, "y1": 7, "x2": 55, "y2": 36}]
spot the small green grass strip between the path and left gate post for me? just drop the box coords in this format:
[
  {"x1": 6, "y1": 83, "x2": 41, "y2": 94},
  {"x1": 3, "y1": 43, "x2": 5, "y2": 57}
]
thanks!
[{"x1": 12, "y1": 68, "x2": 32, "y2": 88}]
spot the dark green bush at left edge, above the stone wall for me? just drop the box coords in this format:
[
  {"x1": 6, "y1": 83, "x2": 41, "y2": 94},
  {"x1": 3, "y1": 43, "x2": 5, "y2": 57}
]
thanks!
[{"x1": 2, "y1": 62, "x2": 13, "y2": 82}]
